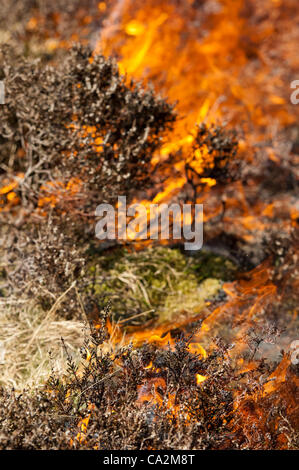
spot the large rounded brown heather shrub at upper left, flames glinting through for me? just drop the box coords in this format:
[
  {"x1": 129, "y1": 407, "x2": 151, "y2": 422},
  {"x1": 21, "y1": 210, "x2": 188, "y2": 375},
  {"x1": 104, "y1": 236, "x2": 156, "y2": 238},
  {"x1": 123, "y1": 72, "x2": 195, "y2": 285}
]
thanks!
[{"x1": 0, "y1": 46, "x2": 175, "y2": 231}]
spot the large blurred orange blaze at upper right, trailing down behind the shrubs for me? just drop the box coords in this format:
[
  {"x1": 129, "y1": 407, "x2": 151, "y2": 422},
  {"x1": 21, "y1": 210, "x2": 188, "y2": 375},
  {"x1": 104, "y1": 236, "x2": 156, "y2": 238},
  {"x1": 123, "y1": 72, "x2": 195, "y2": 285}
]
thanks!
[{"x1": 95, "y1": 0, "x2": 298, "y2": 246}]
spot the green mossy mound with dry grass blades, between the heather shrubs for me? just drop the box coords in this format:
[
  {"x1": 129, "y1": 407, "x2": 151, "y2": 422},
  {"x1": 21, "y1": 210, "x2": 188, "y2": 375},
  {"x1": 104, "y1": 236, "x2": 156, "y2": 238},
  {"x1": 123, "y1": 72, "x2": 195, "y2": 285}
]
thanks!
[{"x1": 90, "y1": 247, "x2": 235, "y2": 324}]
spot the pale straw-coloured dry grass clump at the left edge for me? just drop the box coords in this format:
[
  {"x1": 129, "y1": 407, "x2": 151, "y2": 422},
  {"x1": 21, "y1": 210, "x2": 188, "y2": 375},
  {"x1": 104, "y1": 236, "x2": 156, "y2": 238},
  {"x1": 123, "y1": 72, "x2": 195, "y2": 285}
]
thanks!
[{"x1": 0, "y1": 301, "x2": 84, "y2": 391}]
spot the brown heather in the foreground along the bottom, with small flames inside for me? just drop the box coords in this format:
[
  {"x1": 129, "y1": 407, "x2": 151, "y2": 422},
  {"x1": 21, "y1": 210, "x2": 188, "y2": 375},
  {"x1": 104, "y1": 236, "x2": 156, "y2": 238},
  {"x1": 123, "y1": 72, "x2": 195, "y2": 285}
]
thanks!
[{"x1": 0, "y1": 316, "x2": 298, "y2": 450}]
